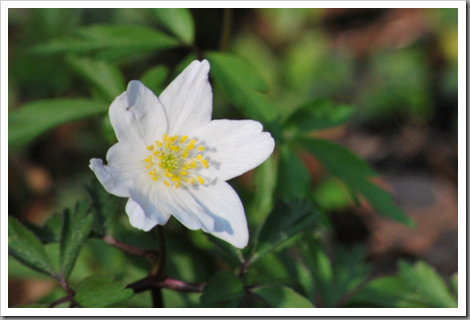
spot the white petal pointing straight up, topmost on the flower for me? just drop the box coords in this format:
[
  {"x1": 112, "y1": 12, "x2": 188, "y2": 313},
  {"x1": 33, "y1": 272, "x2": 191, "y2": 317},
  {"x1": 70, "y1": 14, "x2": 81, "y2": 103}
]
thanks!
[{"x1": 160, "y1": 60, "x2": 212, "y2": 136}]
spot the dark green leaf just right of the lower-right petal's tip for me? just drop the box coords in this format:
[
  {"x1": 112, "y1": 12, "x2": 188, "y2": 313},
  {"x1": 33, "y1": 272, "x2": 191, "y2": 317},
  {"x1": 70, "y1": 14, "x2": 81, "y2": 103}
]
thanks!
[{"x1": 250, "y1": 200, "x2": 319, "y2": 262}]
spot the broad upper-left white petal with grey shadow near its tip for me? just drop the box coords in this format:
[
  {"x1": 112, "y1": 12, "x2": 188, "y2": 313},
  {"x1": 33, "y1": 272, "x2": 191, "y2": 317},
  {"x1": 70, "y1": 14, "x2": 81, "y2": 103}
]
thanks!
[{"x1": 109, "y1": 80, "x2": 168, "y2": 149}]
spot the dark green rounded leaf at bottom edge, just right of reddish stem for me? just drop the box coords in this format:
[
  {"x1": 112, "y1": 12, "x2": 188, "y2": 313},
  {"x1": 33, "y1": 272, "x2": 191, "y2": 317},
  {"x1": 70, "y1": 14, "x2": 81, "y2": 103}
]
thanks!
[{"x1": 200, "y1": 272, "x2": 245, "y2": 306}]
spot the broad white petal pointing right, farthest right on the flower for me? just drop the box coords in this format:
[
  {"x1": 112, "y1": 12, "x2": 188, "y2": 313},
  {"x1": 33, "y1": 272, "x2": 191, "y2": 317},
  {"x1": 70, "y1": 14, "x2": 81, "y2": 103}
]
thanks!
[{"x1": 198, "y1": 120, "x2": 274, "y2": 180}]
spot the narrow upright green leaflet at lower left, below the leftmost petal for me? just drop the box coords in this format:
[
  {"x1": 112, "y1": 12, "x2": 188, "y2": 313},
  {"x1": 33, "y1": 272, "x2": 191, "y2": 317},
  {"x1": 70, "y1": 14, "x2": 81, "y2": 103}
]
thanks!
[{"x1": 60, "y1": 201, "x2": 94, "y2": 279}]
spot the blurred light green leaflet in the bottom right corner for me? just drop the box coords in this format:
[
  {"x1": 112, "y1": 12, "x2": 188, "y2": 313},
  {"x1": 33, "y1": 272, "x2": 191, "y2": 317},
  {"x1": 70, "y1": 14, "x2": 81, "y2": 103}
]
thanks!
[{"x1": 398, "y1": 261, "x2": 457, "y2": 308}]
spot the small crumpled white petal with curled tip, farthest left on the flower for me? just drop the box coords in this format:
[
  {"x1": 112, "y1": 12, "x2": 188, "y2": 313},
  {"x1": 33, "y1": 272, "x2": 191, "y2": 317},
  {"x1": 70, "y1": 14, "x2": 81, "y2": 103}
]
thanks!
[{"x1": 90, "y1": 142, "x2": 146, "y2": 197}]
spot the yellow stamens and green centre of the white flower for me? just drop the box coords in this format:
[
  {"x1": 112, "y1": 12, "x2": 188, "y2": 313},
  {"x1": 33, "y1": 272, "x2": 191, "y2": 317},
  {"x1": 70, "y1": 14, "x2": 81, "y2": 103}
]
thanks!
[{"x1": 144, "y1": 134, "x2": 209, "y2": 189}]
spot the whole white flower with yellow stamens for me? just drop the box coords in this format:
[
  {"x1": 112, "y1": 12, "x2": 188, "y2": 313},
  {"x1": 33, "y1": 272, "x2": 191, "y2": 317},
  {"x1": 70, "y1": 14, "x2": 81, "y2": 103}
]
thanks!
[{"x1": 90, "y1": 60, "x2": 274, "y2": 248}]
